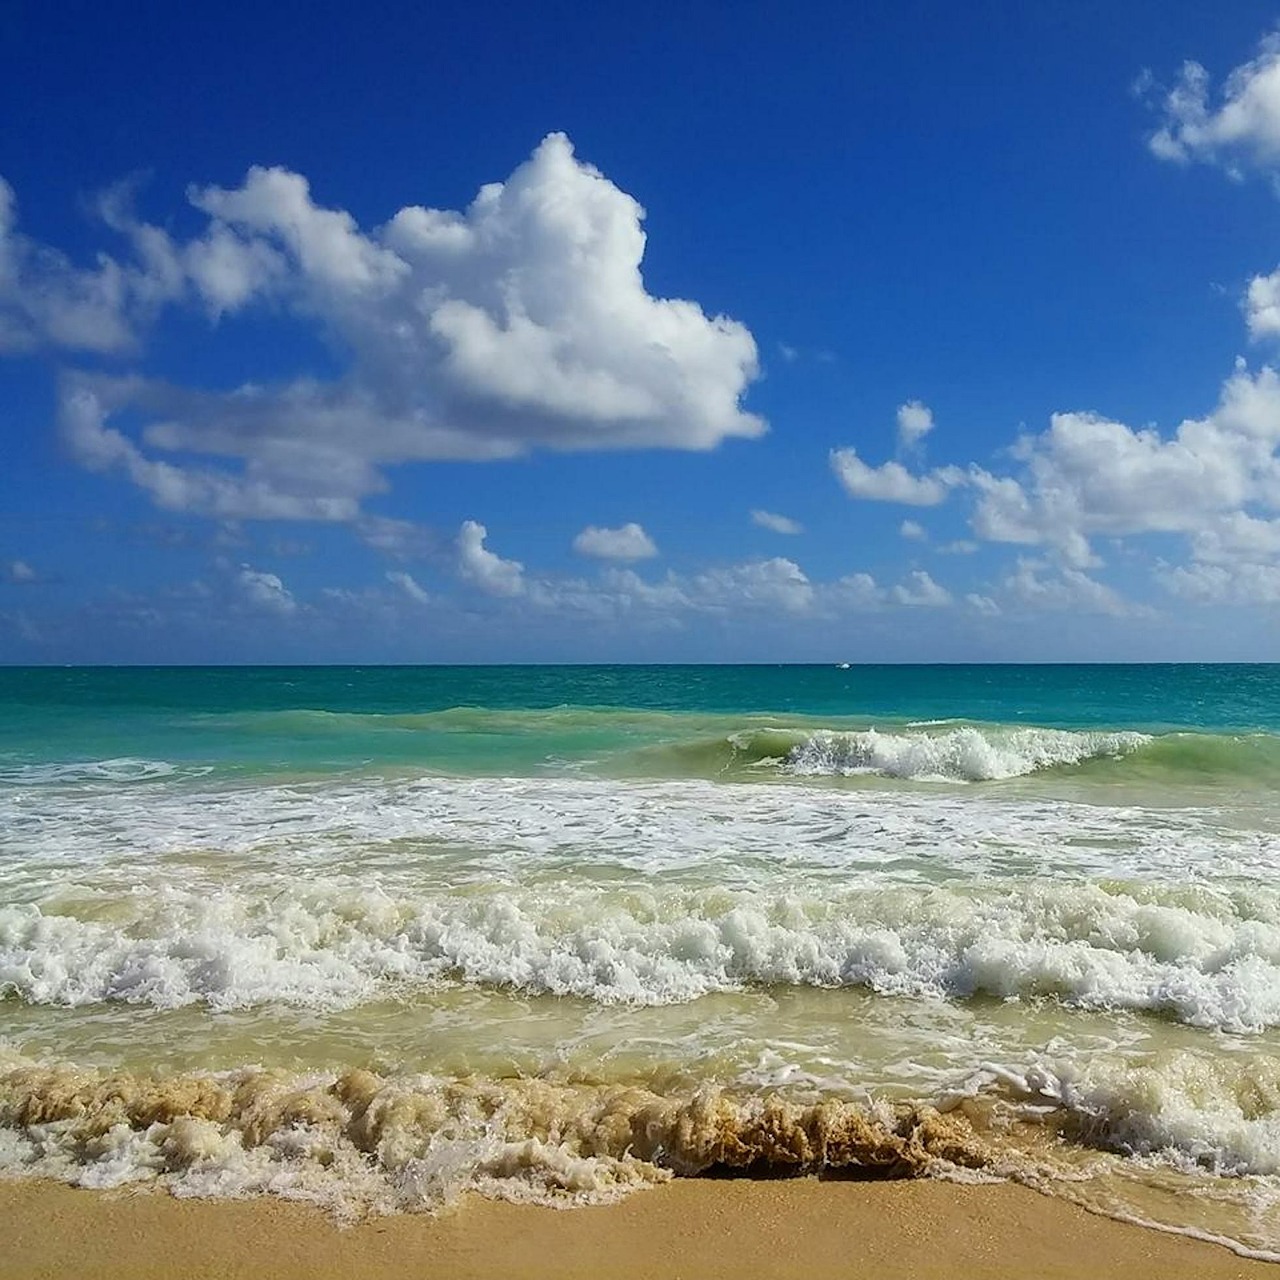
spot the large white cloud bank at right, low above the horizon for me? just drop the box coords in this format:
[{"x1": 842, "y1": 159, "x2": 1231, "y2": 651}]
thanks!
[{"x1": 831, "y1": 345, "x2": 1280, "y2": 616}]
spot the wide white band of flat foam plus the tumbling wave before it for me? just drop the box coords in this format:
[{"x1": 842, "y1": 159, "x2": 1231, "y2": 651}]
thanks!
[{"x1": 0, "y1": 778, "x2": 1280, "y2": 1029}]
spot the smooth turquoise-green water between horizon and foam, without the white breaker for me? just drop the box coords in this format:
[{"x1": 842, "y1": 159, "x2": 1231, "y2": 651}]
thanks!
[{"x1": 0, "y1": 666, "x2": 1280, "y2": 773}]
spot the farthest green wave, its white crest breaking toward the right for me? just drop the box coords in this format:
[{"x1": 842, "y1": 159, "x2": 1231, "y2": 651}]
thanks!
[{"x1": 0, "y1": 707, "x2": 1280, "y2": 786}]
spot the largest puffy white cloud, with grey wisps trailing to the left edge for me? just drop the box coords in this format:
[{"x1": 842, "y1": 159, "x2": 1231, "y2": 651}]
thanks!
[{"x1": 12, "y1": 134, "x2": 765, "y2": 520}]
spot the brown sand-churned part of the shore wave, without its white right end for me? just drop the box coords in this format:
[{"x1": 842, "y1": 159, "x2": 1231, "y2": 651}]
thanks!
[{"x1": 0, "y1": 1062, "x2": 992, "y2": 1215}]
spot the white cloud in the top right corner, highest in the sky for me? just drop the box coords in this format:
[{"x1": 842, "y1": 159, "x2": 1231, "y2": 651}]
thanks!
[{"x1": 1149, "y1": 35, "x2": 1280, "y2": 177}]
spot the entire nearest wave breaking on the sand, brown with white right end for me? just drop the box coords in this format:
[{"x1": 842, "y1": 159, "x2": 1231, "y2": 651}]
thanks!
[{"x1": 0, "y1": 1050, "x2": 1280, "y2": 1260}]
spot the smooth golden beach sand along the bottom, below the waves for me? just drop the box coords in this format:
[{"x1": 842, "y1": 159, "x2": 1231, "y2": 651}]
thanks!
[{"x1": 0, "y1": 1178, "x2": 1280, "y2": 1280}]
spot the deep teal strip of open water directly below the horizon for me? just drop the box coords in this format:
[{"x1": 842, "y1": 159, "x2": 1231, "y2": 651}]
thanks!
[{"x1": 0, "y1": 664, "x2": 1280, "y2": 731}]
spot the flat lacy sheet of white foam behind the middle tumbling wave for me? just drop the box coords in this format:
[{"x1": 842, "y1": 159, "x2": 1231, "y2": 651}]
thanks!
[{"x1": 0, "y1": 762, "x2": 1264, "y2": 885}]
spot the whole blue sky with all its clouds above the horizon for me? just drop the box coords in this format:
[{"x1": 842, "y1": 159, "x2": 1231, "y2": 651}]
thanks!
[{"x1": 0, "y1": 0, "x2": 1280, "y2": 663}]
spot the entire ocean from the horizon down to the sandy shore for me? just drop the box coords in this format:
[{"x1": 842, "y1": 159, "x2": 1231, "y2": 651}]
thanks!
[{"x1": 0, "y1": 664, "x2": 1280, "y2": 1257}]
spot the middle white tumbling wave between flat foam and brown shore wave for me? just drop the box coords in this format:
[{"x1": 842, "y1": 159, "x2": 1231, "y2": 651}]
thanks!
[{"x1": 0, "y1": 879, "x2": 1280, "y2": 1030}]
